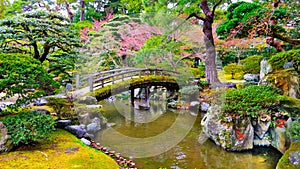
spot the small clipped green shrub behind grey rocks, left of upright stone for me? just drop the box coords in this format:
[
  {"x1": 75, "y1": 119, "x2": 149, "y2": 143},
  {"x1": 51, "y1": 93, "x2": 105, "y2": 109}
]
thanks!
[{"x1": 241, "y1": 56, "x2": 262, "y2": 74}]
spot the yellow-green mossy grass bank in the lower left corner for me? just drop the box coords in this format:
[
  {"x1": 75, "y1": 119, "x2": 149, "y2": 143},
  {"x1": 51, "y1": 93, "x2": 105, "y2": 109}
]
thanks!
[{"x1": 0, "y1": 129, "x2": 119, "y2": 169}]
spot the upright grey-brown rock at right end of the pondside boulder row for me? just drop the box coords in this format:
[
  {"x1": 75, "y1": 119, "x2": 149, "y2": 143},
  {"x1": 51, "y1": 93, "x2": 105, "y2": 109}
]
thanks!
[{"x1": 270, "y1": 127, "x2": 289, "y2": 153}]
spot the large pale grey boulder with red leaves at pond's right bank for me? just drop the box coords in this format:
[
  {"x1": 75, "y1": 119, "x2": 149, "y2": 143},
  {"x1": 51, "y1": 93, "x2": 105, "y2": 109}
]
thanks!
[{"x1": 201, "y1": 105, "x2": 254, "y2": 151}]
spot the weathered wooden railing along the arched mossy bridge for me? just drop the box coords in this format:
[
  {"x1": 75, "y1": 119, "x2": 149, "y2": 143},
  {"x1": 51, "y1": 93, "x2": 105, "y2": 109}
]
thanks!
[{"x1": 76, "y1": 68, "x2": 178, "y2": 92}]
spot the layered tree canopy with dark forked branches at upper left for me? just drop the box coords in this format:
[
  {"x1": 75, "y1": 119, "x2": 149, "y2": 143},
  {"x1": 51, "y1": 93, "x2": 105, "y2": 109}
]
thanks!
[{"x1": 0, "y1": 12, "x2": 80, "y2": 62}]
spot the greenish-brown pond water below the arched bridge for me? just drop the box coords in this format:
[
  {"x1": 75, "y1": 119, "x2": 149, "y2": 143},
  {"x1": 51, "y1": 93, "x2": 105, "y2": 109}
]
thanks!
[{"x1": 95, "y1": 100, "x2": 281, "y2": 169}]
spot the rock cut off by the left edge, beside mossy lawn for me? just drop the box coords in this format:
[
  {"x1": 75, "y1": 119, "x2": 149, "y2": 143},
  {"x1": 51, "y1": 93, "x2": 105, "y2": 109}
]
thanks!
[{"x1": 0, "y1": 122, "x2": 13, "y2": 153}]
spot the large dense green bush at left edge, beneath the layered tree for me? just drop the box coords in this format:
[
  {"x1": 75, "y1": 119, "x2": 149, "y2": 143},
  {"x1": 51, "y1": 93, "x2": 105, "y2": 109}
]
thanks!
[{"x1": 0, "y1": 53, "x2": 58, "y2": 106}]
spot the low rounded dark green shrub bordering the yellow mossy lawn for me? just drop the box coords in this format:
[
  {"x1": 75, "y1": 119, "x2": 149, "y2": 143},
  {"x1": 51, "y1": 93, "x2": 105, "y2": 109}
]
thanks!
[{"x1": 3, "y1": 112, "x2": 55, "y2": 145}]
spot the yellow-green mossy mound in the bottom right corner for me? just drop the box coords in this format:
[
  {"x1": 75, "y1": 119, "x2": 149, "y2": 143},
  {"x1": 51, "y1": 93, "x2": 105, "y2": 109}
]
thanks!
[{"x1": 277, "y1": 142, "x2": 300, "y2": 169}]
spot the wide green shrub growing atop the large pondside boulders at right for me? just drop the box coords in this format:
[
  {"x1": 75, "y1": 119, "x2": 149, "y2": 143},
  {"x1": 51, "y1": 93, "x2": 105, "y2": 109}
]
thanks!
[{"x1": 223, "y1": 85, "x2": 284, "y2": 118}]
